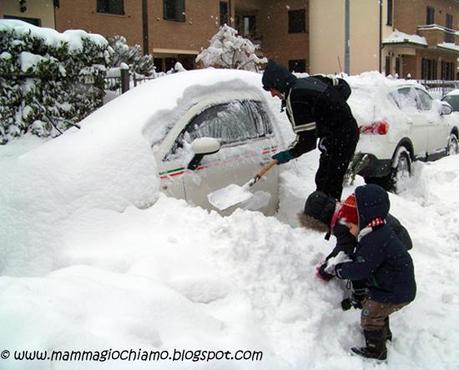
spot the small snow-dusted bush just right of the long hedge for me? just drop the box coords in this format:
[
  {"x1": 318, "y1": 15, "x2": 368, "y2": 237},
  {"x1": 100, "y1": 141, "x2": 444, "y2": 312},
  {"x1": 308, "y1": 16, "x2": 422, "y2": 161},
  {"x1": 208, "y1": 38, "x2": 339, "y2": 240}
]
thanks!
[{"x1": 108, "y1": 36, "x2": 155, "y2": 76}]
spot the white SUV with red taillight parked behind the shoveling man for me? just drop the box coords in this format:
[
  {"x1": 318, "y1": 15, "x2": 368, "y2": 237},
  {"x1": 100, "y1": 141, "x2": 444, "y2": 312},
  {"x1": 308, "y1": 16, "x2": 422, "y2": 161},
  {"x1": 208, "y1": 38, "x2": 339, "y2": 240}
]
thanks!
[{"x1": 349, "y1": 73, "x2": 458, "y2": 189}]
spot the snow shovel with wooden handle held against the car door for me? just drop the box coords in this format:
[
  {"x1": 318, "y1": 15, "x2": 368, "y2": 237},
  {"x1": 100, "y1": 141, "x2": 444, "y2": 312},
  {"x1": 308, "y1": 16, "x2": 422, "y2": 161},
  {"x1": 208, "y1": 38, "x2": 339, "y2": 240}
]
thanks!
[{"x1": 207, "y1": 159, "x2": 277, "y2": 211}]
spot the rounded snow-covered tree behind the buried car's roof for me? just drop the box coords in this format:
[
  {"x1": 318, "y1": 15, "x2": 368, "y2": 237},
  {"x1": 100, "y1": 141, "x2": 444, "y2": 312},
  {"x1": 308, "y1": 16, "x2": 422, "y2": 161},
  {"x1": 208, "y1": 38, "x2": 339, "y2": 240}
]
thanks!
[{"x1": 196, "y1": 24, "x2": 268, "y2": 71}]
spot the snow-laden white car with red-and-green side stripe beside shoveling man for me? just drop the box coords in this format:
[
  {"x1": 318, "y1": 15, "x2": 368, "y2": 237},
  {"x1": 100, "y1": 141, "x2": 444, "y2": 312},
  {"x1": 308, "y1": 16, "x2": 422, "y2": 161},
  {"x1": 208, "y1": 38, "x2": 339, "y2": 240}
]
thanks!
[{"x1": 114, "y1": 69, "x2": 283, "y2": 215}]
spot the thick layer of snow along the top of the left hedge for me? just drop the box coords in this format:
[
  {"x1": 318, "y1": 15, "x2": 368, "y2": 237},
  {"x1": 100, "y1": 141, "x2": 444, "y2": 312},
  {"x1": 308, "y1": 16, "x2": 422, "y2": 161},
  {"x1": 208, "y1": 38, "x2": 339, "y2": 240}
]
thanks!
[{"x1": 0, "y1": 19, "x2": 108, "y2": 51}]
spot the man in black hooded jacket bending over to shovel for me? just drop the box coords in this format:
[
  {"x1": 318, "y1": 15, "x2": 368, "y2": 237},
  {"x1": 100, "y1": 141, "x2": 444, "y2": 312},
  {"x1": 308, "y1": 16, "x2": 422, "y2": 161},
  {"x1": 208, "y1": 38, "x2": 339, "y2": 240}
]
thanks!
[{"x1": 262, "y1": 60, "x2": 359, "y2": 200}]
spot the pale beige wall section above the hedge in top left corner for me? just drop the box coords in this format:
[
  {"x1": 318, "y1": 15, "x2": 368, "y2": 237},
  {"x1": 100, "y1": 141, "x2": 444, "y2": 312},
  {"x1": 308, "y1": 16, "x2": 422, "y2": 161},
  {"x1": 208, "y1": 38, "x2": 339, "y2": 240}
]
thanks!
[{"x1": 0, "y1": 0, "x2": 55, "y2": 28}]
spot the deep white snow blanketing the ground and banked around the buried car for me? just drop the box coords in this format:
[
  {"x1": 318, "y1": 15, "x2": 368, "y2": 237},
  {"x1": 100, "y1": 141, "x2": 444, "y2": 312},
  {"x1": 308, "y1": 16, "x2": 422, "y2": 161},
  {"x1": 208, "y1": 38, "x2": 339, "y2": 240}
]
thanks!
[{"x1": 0, "y1": 71, "x2": 459, "y2": 370}]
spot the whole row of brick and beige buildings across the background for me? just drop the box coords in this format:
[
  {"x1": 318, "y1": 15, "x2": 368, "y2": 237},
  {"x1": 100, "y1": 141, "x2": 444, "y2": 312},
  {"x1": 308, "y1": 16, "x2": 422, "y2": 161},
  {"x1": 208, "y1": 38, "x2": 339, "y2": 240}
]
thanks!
[{"x1": 0, "y1": 0, "x2": 459, "y2": 79}]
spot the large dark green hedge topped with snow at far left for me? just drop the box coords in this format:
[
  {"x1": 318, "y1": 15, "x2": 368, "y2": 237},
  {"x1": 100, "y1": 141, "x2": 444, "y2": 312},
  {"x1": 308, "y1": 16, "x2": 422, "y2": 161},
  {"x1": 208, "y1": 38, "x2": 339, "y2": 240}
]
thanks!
[{"x1": 0, "y1": 20, "x2": 113, "y2": 144}]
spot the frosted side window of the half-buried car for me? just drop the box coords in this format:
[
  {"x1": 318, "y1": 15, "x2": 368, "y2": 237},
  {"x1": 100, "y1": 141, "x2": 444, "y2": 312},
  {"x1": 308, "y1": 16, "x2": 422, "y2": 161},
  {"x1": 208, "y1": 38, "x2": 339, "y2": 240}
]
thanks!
[{"x1": 171, "y1": 100, "x2": 273, "y2": 154}]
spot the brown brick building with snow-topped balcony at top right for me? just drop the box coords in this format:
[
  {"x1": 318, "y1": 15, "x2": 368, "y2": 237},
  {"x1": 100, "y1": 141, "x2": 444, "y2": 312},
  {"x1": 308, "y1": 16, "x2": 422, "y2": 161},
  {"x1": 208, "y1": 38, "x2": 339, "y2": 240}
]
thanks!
[{"x1": 382, "y1": 0, "x2": 459, "y2": 80}]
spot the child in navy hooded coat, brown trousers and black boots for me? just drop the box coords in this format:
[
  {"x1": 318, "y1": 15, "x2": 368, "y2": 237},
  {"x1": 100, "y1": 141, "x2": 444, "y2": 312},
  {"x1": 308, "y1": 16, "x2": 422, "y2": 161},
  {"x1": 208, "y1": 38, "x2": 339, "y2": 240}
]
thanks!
[{"x1": 326, "y1": 185, "x2": 416, "y2": 360}]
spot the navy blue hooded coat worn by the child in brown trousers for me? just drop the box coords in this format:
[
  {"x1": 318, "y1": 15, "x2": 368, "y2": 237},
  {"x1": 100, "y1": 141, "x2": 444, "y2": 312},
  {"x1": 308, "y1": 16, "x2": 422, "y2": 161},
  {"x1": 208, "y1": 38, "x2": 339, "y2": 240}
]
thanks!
[{"x1": 336, "y1": 185, "x2": 416, "y2": 304}]
